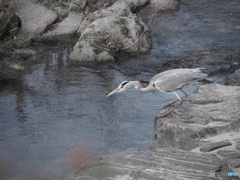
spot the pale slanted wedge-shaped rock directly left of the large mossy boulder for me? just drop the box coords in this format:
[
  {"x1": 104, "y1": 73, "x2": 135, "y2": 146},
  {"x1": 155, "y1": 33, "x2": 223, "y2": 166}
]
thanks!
[{"x1": 41, "y1": 12, "x2": 84, "y2": 40}]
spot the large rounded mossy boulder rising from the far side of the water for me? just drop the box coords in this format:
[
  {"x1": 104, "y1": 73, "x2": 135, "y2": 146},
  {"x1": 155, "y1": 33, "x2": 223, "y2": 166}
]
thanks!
[{"x1": 70, "y1": 15, "x2": 151, "y2": 62}]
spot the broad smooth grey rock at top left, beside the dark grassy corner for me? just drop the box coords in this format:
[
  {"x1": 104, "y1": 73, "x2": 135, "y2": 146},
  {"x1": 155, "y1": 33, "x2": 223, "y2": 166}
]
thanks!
[{"x1": 16, "y1": 0, "x2": 58, "y2": 38}]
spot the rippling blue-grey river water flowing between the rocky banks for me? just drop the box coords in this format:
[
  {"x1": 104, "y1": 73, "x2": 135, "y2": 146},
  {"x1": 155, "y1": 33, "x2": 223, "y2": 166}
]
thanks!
[{"x1": 0, "y1": 1, "x2": 239, "y2": 180}]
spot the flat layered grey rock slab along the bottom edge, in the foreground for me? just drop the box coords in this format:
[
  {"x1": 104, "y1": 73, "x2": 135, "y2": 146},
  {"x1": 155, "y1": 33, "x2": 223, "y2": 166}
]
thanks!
[{"x1": 67, "y1": 148, "x2": 236, "y2": 180}]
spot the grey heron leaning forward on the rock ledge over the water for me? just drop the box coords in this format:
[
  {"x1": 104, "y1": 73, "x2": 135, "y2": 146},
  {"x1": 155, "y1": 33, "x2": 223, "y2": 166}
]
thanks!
[{"x1": 107, "y1": 68, "x2": 208, "y2": 119}]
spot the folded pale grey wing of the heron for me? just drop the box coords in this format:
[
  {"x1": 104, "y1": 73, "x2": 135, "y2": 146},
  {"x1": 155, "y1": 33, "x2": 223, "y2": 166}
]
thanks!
[{"x1": 150, "y1": 68, "x2": 207, "y2": 92}]
